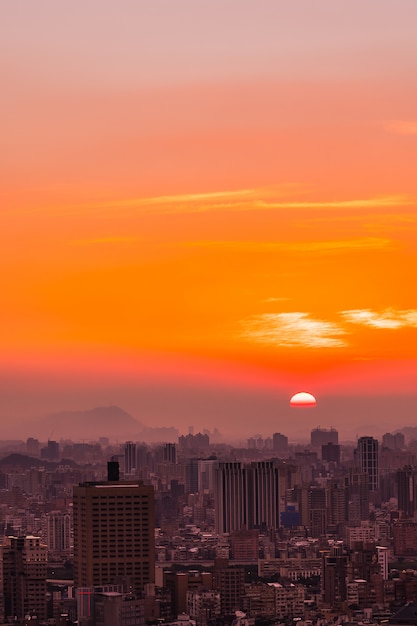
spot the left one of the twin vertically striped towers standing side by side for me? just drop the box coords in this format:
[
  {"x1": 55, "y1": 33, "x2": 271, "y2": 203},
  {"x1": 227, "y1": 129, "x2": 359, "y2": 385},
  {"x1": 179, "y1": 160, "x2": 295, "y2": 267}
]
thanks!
[{"x1": 214, "y1": 463, "x2": 249, "y2": 533}]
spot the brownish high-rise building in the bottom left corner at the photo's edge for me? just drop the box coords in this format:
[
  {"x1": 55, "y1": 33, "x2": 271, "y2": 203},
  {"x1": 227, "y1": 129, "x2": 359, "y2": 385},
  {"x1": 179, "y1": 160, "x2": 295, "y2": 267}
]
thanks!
[{"x1": 3, "y1": 535, "x2": 48, "y2": 622}]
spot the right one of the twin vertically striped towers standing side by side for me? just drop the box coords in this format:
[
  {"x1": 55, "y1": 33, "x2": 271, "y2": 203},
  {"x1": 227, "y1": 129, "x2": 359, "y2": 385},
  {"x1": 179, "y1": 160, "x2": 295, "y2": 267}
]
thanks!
[{"x1": 248, "y1": 461, "x2": 280, "y2": 528}]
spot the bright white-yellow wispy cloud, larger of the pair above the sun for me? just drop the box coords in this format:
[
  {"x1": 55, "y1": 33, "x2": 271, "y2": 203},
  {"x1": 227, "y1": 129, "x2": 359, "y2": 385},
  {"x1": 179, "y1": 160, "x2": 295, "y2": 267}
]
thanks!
[{"x1": 241, "y1": 312, "x2": 348, "y2": 348}]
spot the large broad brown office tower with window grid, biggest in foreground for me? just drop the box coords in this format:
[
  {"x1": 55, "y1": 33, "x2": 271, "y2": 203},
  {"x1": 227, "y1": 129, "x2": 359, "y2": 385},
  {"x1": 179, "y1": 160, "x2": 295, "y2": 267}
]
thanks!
[{"x1": 73, "y1": 481, "x2": 155, "y2": 591}]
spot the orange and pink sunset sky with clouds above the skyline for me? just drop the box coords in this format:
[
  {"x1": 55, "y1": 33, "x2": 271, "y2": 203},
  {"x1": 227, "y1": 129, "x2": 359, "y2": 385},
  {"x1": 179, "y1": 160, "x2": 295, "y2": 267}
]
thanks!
[{"x1": 0, "y1": 0, "x2": 417, "y2": 436}]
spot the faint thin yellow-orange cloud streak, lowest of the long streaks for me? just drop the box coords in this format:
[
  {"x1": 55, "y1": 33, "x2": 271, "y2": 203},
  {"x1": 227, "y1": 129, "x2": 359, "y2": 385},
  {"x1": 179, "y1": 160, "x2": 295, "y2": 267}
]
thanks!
[{"x1": 183, "y1": 237, "x2": 394, "y2": 253}]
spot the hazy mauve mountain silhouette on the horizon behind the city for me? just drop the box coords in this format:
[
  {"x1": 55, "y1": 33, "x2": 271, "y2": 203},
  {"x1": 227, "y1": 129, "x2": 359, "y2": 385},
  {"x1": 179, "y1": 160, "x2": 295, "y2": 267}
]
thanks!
[{"x1": 32, "y1": 406, "x2": 144, "y2": 441}]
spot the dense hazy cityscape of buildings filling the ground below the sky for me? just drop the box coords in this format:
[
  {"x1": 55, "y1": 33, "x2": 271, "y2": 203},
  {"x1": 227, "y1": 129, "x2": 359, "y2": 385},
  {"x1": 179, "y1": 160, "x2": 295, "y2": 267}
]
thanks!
[{"x1": 0, "y1": 427, "x2": 417, "y2": 626}]
